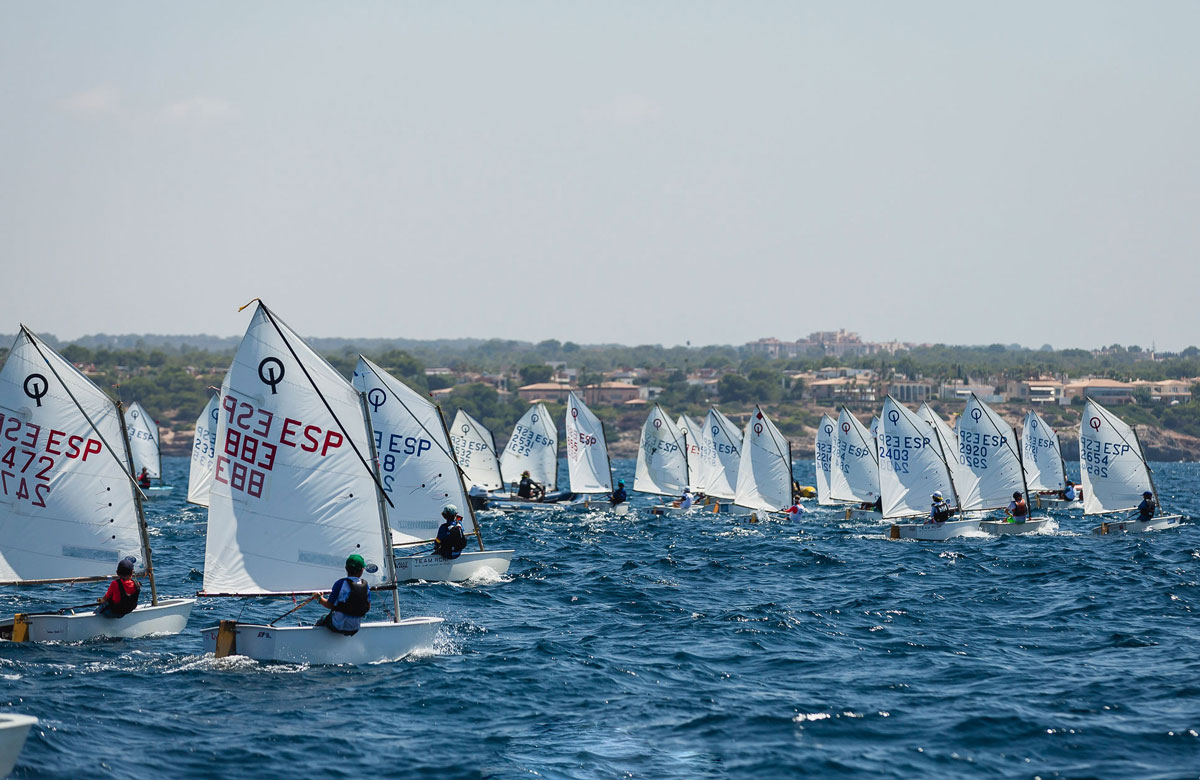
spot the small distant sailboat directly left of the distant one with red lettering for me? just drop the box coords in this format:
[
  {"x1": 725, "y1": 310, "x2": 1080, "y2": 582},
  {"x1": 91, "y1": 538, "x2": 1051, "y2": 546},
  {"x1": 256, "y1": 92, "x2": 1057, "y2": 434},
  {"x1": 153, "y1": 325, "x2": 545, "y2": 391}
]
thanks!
[{"x1": 487, "y1": 402, "x2": 575, "y2": 512}]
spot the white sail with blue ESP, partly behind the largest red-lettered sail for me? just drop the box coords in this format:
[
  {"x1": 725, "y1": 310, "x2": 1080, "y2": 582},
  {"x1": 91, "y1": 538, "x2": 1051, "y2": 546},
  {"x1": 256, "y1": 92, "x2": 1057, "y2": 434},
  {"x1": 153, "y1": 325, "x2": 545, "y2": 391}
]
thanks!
[{"x1": 354, "y1": 355, "x2": 478, "y2": 545}]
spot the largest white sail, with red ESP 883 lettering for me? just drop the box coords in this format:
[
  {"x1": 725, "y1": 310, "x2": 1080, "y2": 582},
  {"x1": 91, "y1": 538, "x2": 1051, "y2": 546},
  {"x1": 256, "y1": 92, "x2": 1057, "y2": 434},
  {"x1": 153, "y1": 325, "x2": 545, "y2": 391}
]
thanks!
[{"x1": 204, "y1": 304, "x2": 391, "y2": 595}]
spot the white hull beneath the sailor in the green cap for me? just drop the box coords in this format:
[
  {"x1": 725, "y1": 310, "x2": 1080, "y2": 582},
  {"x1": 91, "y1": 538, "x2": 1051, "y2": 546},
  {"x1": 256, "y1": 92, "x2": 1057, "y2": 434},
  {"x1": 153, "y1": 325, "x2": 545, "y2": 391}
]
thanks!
[{"x1": 200, "y1": 618, "x2": 444, "y2": 665}]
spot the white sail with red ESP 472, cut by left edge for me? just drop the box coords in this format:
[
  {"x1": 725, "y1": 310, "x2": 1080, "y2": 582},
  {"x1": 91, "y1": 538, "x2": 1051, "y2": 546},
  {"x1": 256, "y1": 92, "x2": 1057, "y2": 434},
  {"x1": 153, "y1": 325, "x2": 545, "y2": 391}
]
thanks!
[{"x1": 0, "y1": 326, "x2": 145, "y2": 582}]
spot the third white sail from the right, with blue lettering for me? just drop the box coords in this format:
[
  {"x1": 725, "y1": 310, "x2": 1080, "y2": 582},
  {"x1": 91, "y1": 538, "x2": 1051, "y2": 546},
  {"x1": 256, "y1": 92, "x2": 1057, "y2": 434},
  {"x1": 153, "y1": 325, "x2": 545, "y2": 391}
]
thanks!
[{"x1": 954, "y1": 392, "x2": 1025, "y2": 511}]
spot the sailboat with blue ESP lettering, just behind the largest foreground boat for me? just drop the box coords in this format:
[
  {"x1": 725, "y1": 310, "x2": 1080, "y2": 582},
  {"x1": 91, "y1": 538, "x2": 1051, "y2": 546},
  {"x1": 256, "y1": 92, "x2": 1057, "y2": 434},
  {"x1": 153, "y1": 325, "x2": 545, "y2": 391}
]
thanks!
[{"x1": 354, "y1": 355, "x2": 512, "y2": 582}]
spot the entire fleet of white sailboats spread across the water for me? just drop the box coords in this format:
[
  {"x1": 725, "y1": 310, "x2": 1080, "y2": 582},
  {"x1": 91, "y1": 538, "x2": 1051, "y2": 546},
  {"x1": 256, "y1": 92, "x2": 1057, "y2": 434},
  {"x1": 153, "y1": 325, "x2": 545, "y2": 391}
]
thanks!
[{"x1": 0, "y1": 302, "x2": 1182, "y2": 664}]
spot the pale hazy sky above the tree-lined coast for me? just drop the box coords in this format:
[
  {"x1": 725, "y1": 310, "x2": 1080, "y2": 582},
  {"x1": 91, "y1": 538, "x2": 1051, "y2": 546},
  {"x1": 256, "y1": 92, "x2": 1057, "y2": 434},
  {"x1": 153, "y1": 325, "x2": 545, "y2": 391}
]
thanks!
[{"x1": 0, "y1": 0, "x2": 1200, "y2": 349}]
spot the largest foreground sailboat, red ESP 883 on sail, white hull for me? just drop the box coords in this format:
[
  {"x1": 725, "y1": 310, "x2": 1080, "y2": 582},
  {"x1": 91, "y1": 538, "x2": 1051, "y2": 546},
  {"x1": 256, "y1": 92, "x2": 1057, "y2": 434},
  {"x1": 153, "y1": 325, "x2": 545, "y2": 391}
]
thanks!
[{"x1": 200, "y1": 302, "x2": 443, "y2": 664}]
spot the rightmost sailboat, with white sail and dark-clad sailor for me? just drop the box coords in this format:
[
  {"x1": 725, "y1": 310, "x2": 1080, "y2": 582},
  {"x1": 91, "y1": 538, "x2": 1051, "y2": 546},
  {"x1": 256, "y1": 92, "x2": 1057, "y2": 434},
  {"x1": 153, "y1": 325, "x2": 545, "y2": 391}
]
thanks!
[{"x1": 1079, "y1": 398, "x2": 1183, "y2": 535}]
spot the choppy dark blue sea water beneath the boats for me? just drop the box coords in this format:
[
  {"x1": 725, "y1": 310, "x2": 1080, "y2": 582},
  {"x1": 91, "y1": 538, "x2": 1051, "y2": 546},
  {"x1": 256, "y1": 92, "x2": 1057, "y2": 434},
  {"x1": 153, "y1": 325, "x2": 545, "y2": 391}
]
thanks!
[{"x1": 0, "y1": 458, "x2": 1200, "y2": 780}]
